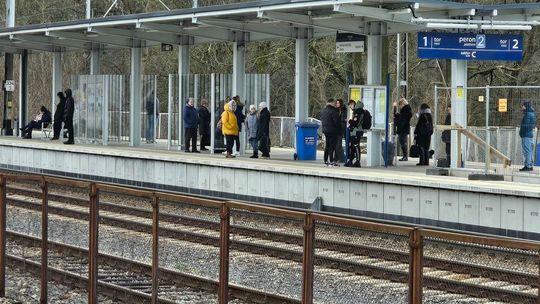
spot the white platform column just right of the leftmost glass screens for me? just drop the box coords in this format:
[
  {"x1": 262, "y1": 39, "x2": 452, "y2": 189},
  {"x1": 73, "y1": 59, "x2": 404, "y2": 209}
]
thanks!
[{"x1": 129, "y1": 47, "x2": 142, "y2": 147}]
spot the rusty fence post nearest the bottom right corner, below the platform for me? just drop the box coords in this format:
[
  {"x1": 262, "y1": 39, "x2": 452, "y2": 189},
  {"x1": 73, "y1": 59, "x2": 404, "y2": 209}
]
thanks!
[{"x1": 409, "y1": 228, "x2": 424, "y2": 304}]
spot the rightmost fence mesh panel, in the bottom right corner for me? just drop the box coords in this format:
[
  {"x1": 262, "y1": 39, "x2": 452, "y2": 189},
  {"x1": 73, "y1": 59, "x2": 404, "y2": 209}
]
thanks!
[{"x1": 423, "y1": 238, "x2": 538, "y2": 303}]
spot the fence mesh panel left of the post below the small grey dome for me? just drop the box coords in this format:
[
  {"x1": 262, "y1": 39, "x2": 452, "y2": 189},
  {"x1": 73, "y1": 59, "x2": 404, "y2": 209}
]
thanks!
[{"x1": 229, "y1": 209, "x2": 303, "y2": 299}]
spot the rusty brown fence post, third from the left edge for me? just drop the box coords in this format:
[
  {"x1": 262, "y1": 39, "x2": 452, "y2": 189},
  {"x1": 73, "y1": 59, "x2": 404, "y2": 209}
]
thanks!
[{"x1": 88, "y1": 183, "x2": 99, "y2": 304}]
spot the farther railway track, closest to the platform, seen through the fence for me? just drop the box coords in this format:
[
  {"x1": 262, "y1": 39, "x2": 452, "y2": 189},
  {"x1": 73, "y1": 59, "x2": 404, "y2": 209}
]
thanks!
[{"x1": 7, "y1": 187, "x2": 538, "y2": 303}]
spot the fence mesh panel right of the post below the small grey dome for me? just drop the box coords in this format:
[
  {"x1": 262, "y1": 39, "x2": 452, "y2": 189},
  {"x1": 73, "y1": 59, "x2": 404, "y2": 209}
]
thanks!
[{"x1": 314, "y1": 222, "x2": 409, "y2": 304}]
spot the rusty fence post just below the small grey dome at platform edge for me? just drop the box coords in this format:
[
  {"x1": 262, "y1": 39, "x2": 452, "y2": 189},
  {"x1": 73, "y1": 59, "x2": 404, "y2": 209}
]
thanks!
[{"x1": 302, "y1": 213, "x2": 315, "y2": 304}]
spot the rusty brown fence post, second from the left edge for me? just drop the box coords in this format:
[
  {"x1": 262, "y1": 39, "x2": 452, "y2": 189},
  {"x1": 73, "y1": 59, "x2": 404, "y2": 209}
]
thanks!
[{"x1": 39, "y1": 178, "x2": 49, "y2": 304}]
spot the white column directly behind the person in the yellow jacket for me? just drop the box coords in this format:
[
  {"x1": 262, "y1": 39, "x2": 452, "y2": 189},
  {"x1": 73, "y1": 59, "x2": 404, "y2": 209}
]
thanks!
[{"x1": 232, "y1": 37, "x2": 246, "y2": 155}]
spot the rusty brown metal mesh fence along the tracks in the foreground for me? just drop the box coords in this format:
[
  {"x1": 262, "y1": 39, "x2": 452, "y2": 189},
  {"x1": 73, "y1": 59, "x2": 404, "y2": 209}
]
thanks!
[{"x1": 0, "y1": 174, "x2": 540, "y2": 304}]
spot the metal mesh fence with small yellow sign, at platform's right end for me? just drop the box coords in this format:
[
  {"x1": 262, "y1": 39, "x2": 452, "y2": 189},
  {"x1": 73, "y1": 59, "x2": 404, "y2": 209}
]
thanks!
[{"x1": 432, "y1": 86, "x2": 540, "y2": 171}]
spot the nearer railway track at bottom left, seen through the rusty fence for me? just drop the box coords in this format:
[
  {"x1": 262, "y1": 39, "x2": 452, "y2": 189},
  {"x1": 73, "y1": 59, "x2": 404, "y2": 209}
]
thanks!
[{"x1": 7, "y1": 231, "x2": 300, "y2": 304}]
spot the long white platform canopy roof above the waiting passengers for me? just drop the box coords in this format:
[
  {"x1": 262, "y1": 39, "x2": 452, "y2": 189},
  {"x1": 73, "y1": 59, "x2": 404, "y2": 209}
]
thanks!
[{"x1": 0, "y1": 0, "x2": 540, "y2": 53}]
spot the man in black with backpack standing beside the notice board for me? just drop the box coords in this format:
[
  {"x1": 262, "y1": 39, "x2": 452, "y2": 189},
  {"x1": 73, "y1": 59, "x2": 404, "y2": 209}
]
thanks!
[{"x1": 345, "y1": 100, "x2": 372, "y2": 168}]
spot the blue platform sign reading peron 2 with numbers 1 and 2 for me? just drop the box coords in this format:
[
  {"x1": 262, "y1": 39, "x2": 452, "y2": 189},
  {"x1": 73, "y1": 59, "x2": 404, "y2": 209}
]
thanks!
[{"x1": 418, "y1": 32, "x2": 523, "y2": 61}]
